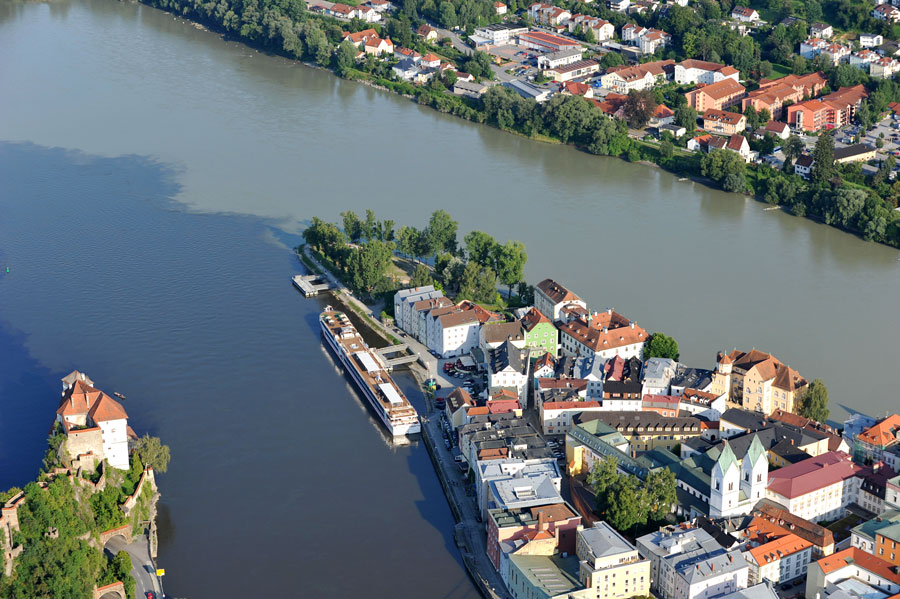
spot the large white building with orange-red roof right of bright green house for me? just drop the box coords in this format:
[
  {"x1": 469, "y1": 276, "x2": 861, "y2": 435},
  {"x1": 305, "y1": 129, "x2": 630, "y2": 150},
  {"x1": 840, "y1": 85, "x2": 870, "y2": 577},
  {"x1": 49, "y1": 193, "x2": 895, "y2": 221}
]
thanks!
[{"x1": 559, "y1": 308, "x2": 648, "y2": 360}]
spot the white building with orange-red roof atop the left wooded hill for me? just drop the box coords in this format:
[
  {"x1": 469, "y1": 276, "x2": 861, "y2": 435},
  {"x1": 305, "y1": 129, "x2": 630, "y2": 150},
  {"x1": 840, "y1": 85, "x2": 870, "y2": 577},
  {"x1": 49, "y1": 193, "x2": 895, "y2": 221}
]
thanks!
[{"x1": 56, "y1": 370, "x2": 134, "y2": 472}]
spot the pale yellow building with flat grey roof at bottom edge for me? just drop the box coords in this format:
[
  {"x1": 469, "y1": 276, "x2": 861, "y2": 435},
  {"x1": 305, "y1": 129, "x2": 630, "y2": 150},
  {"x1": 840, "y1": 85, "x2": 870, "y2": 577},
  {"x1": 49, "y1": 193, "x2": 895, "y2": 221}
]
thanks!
[{"x1": 575, "y1": 520, "x2": 650, "y2": 599}]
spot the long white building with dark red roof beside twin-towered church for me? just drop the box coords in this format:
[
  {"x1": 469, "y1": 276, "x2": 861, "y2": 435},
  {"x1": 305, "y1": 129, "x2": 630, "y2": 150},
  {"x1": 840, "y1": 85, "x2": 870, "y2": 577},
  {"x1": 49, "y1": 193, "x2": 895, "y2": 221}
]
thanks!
[{"x1": 766, "y1": 451, "x2": 861, "y2": 522}]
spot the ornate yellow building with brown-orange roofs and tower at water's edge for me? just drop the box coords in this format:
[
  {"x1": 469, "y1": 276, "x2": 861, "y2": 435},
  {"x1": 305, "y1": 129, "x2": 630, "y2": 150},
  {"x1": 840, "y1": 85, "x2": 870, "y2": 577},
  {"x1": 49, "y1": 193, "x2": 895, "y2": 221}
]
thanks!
[{"x1": 711, "y1": 349, "x2": 809, "y2": 414}]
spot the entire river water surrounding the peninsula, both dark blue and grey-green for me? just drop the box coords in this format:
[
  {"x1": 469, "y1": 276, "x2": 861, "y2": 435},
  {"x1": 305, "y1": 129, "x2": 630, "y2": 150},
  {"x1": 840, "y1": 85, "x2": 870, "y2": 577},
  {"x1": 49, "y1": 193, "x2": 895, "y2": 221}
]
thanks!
[{"x1": 0, "y1": 0, "x2": 900, "y2": 598}]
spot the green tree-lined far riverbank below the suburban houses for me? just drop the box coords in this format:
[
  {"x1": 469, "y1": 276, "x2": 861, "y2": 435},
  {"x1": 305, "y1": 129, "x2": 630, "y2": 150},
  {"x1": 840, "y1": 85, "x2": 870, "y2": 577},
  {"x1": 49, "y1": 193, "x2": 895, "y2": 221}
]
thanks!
[{"x1": 140, "y1": 0, "x2": 900, "y2": 247}]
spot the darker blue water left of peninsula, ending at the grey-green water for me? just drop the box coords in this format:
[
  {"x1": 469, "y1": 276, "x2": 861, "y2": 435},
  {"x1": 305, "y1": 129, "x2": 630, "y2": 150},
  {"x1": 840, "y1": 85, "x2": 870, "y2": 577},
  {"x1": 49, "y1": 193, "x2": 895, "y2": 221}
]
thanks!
[{"x1": 0, "y1": 143, "x2": 477, "y2": 598}]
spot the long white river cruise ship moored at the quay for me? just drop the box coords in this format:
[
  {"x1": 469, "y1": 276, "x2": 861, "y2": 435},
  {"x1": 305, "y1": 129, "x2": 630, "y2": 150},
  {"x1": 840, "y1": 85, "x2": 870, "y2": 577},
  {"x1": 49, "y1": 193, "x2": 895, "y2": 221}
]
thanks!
[{"x1": 319, "y1": 306, "x2": 421, "y2": 437}]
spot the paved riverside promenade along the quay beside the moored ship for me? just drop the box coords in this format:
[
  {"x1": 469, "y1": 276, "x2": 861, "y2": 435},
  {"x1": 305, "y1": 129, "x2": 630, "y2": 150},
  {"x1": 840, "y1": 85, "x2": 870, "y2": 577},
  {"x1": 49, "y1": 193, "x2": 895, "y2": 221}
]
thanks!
[{"x1": 301, "y1": 247, "x2": 509, "y2": 599}]
